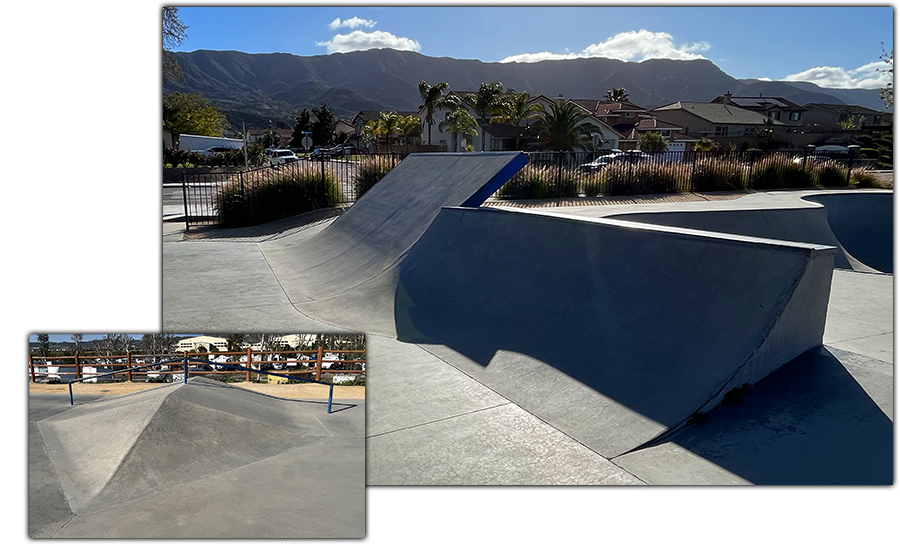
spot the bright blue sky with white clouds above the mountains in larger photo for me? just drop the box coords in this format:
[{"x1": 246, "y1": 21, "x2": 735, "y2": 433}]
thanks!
[{"x1": 177, "y1": 6, "x2": 894, "y2": 88}]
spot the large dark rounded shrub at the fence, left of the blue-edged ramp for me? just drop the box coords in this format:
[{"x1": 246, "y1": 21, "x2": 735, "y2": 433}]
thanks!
[{"x1": 217, "y1": 164, "x2": 342, "y2": 227}]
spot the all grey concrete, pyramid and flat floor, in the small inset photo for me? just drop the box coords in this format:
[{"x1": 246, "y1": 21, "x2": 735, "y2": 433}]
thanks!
[{"x1": 28, "y1": 378, "x2": 365, "y2": 538}]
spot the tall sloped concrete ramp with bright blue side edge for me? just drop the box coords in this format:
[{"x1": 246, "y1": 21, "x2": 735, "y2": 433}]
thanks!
[{"x1": 261, "y1": 152, "x2": 527, "y2": 304}]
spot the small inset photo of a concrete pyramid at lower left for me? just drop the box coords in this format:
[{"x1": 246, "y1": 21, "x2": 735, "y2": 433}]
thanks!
[{"x1": 27, "y1": 333, "x2": 366, "y2": 538}]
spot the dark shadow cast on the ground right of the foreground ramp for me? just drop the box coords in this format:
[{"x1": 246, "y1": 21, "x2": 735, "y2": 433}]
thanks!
[{"x1": 636, "y1": 348, "x2": 894, "y2": 485}]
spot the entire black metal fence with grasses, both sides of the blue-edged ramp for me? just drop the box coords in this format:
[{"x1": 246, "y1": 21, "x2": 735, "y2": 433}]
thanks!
[{"x1": 182, "y1": 150, "x2": 875, "y2": 229}]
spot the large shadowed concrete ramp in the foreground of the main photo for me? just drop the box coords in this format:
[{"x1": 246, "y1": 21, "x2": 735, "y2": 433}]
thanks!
[{"x1": 395, "y1": 208, "x2": 834, "y2": 458}]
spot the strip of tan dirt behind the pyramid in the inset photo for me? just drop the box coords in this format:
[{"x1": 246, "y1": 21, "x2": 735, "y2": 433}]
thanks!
[{"x1": 28, "y1": 381, "x2": 366, "y2": 399}]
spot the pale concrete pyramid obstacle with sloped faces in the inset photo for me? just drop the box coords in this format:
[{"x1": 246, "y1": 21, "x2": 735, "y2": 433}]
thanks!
[{"x1": 37, "y1": 377, "x2": 364, "y2": 536}]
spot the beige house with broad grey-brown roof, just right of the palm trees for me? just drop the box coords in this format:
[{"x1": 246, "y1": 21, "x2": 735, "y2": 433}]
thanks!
[{"x1": 650, "y1": 101, "x2": 785, "y2": 147}]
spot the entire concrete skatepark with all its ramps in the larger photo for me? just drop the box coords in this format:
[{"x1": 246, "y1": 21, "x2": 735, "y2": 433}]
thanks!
[{"x1": 163, "y1": 153, "x2": 893, "y2": 485}]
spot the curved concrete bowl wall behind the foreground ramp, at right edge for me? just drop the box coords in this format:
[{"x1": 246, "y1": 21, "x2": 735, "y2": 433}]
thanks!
[{"x1": 609, "y1": 192, "x2": 893, "y2": 273}]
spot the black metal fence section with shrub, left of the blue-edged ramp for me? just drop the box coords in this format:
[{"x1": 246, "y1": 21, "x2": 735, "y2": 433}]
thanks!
[{"x1": 182, "y1": 153, "x2": 405, "y2": 229}]
